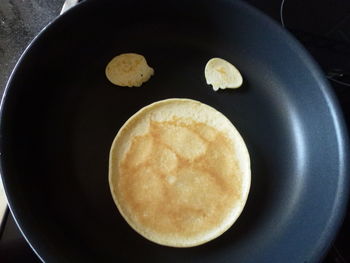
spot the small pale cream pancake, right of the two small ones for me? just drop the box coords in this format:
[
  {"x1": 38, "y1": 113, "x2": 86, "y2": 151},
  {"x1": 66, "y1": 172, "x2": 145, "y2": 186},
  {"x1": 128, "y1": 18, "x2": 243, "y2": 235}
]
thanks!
[{"x1": 204, "y1": 58, "x2": 243, "y2": 91}]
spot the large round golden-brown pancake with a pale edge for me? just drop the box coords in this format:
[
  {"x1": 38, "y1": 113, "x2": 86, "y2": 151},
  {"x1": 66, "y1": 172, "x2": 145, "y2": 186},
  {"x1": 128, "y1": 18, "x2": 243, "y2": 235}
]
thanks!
[{"x1": 109, "y1": 99, "x2": 250, "y2": 247}]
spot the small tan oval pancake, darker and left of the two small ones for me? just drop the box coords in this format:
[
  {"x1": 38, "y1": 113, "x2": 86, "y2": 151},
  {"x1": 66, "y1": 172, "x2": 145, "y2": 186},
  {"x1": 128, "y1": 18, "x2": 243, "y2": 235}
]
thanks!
[{"x1": 106, "y1": 53, "x2": 154, "y2": 87}]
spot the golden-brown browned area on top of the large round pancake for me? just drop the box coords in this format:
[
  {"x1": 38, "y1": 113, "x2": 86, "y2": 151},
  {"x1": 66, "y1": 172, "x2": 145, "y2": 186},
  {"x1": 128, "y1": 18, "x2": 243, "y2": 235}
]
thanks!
[{"x1": 115, "y1": 119, "x2": 241, "y2": 237}]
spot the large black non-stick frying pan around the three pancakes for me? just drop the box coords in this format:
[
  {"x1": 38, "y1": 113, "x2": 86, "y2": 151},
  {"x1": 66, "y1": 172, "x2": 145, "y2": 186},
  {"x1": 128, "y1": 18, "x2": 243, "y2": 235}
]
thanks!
[{"x1": 0, "y1": 0, "x2": 348, "y2": 262}]
